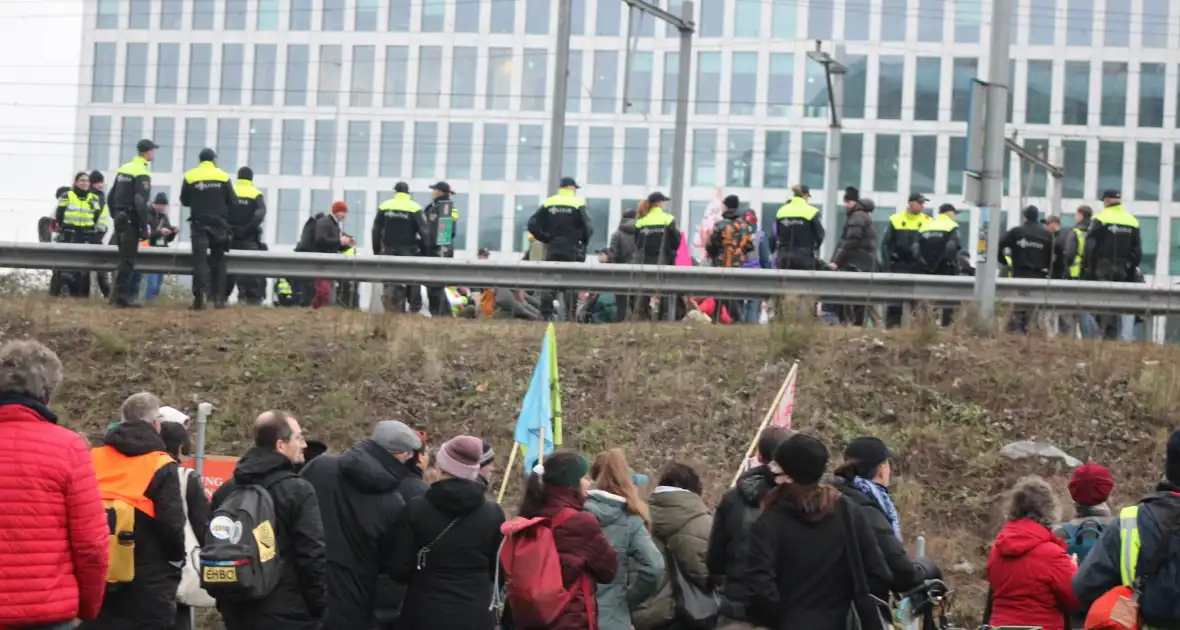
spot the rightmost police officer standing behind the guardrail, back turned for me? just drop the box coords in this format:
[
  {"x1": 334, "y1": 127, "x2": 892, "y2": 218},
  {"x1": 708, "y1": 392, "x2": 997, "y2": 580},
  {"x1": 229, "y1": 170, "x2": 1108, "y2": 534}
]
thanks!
[{"x1": 1081, "y1": 190, "x2": 1143, "y2": 339}]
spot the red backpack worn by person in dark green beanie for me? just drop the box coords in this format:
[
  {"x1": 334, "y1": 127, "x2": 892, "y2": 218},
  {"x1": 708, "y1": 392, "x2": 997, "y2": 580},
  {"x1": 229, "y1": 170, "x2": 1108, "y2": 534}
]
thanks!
[{"x1": 493, "y1": 507, "x2": 597, "y2": 628}]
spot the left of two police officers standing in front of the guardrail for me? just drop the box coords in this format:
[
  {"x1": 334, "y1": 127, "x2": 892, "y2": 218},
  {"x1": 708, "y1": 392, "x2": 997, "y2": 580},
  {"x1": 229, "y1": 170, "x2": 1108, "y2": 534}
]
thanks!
[{"x1": 106, "y1": 139, "x2": 156, "y2": 308}]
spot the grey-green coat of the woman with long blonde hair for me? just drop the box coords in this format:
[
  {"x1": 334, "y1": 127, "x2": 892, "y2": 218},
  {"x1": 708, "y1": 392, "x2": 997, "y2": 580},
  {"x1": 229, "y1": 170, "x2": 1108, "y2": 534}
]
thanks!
[{"x1": 585, "y1": 490, "x2": 664, "y2": 630}]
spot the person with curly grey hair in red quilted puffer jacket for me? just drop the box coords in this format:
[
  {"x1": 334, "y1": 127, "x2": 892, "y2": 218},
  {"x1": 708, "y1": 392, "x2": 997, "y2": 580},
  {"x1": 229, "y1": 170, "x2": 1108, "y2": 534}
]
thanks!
[{"x1": 0, "y1": 341, "x2": 110, "y2": 630}]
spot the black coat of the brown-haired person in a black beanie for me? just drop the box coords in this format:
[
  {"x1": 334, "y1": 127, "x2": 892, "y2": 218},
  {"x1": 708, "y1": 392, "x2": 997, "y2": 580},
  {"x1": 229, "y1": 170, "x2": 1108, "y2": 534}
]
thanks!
[{"x1": 746, "y1": 486, "x2": 890, "y2": 630}]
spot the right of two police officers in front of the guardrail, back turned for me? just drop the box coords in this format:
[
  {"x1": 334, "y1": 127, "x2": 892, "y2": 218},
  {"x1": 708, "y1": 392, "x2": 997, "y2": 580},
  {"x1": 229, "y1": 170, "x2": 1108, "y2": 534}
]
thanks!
[{"x1": 181, "y1": 149, "x2": 237, "y2": 310}]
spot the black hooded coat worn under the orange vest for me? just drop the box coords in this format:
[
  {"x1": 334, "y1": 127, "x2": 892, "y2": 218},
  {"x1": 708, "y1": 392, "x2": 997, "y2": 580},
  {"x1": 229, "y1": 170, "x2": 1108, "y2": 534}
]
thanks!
[{"x1": 81, "y1": 422, "x2": 184, "y2": 630}]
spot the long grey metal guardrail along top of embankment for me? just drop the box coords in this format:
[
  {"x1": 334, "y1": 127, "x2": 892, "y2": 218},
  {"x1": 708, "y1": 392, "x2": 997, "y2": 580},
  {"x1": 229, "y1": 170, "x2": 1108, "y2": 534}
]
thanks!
[{"x1": 0, "y1": 243, "x2": 1180, "y2": 315}]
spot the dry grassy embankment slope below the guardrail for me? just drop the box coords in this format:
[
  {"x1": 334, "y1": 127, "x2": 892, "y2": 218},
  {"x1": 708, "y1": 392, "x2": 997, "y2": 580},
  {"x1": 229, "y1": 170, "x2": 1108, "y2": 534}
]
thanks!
[{"x1": 0, "y1": 297, "x2": 1180, "y2": 616}]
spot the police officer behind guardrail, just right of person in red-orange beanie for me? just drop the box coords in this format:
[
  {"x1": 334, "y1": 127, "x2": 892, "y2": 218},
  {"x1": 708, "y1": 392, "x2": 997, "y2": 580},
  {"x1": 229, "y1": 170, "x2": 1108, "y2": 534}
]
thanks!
[{"x1": 373, "y1": 182, "x2": 430, "y2": 313}]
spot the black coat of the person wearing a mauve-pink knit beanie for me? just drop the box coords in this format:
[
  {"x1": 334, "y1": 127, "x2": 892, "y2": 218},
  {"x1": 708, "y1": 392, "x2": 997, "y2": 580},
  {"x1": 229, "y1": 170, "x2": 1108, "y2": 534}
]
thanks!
[{"x1": 393, "y1": 479, "x2": 504, "y2": 630}]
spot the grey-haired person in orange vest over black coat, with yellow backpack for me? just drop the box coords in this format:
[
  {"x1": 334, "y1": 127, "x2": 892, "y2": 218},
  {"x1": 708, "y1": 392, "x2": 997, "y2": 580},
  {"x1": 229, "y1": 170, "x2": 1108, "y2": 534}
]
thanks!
[{"x1": 81, "y1": 392, "x2": 185, "y2": 630}]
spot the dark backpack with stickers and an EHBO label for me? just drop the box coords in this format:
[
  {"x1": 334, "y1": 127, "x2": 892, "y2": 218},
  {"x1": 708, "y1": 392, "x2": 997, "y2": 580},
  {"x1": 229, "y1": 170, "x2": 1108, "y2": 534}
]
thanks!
[{"x1": 201, "y1": 473, "x2": 295, "y2": 602}]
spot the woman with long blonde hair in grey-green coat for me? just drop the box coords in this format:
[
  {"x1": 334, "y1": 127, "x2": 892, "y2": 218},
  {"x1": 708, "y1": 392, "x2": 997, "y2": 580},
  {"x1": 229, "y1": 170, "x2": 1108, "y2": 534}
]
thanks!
[{"x1": 585, "y1": 448, "x2": 664, "y2": 630}]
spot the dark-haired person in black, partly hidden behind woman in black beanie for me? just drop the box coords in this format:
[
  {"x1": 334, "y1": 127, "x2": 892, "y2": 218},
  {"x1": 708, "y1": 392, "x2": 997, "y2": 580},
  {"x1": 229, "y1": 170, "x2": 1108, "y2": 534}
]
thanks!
[{"x1": 708, "y1": 427, "x2": 789, "y2": 625}]
